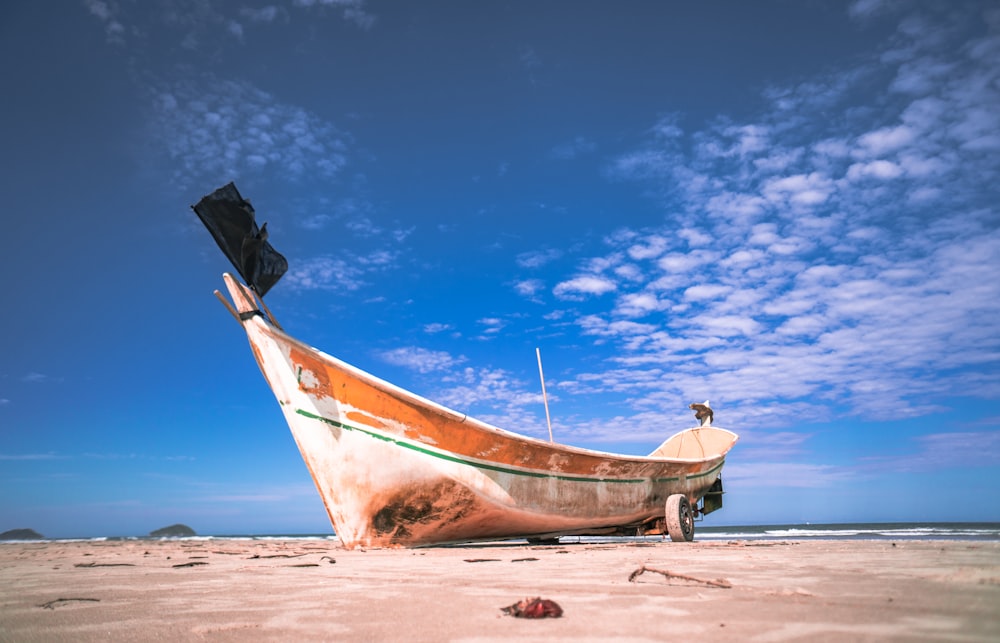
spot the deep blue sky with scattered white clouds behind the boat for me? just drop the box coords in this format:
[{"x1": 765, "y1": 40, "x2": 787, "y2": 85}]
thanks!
[{"x1": 0, "y1": 0, "x2": 1000, "y2": 538}]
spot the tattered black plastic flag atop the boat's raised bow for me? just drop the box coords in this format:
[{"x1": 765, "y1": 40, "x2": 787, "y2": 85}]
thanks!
[{"x1": 191, "y1": 183, "x2": 288, "y2": 297}]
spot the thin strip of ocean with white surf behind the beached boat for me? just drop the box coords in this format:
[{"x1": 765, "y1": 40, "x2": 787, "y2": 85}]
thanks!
[{"x1": 0, "y1": 522, "x2": 1000, "y2": 544}]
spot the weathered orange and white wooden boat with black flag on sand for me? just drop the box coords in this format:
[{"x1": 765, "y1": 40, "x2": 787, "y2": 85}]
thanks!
[{"x1": 193, "y1": 184, "x2": 738, "y2": 549}]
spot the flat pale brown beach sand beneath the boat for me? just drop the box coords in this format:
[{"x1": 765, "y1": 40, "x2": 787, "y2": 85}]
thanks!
[{"x1": 0, "y1": 539, "x2": 1000, "y2": 643}]
